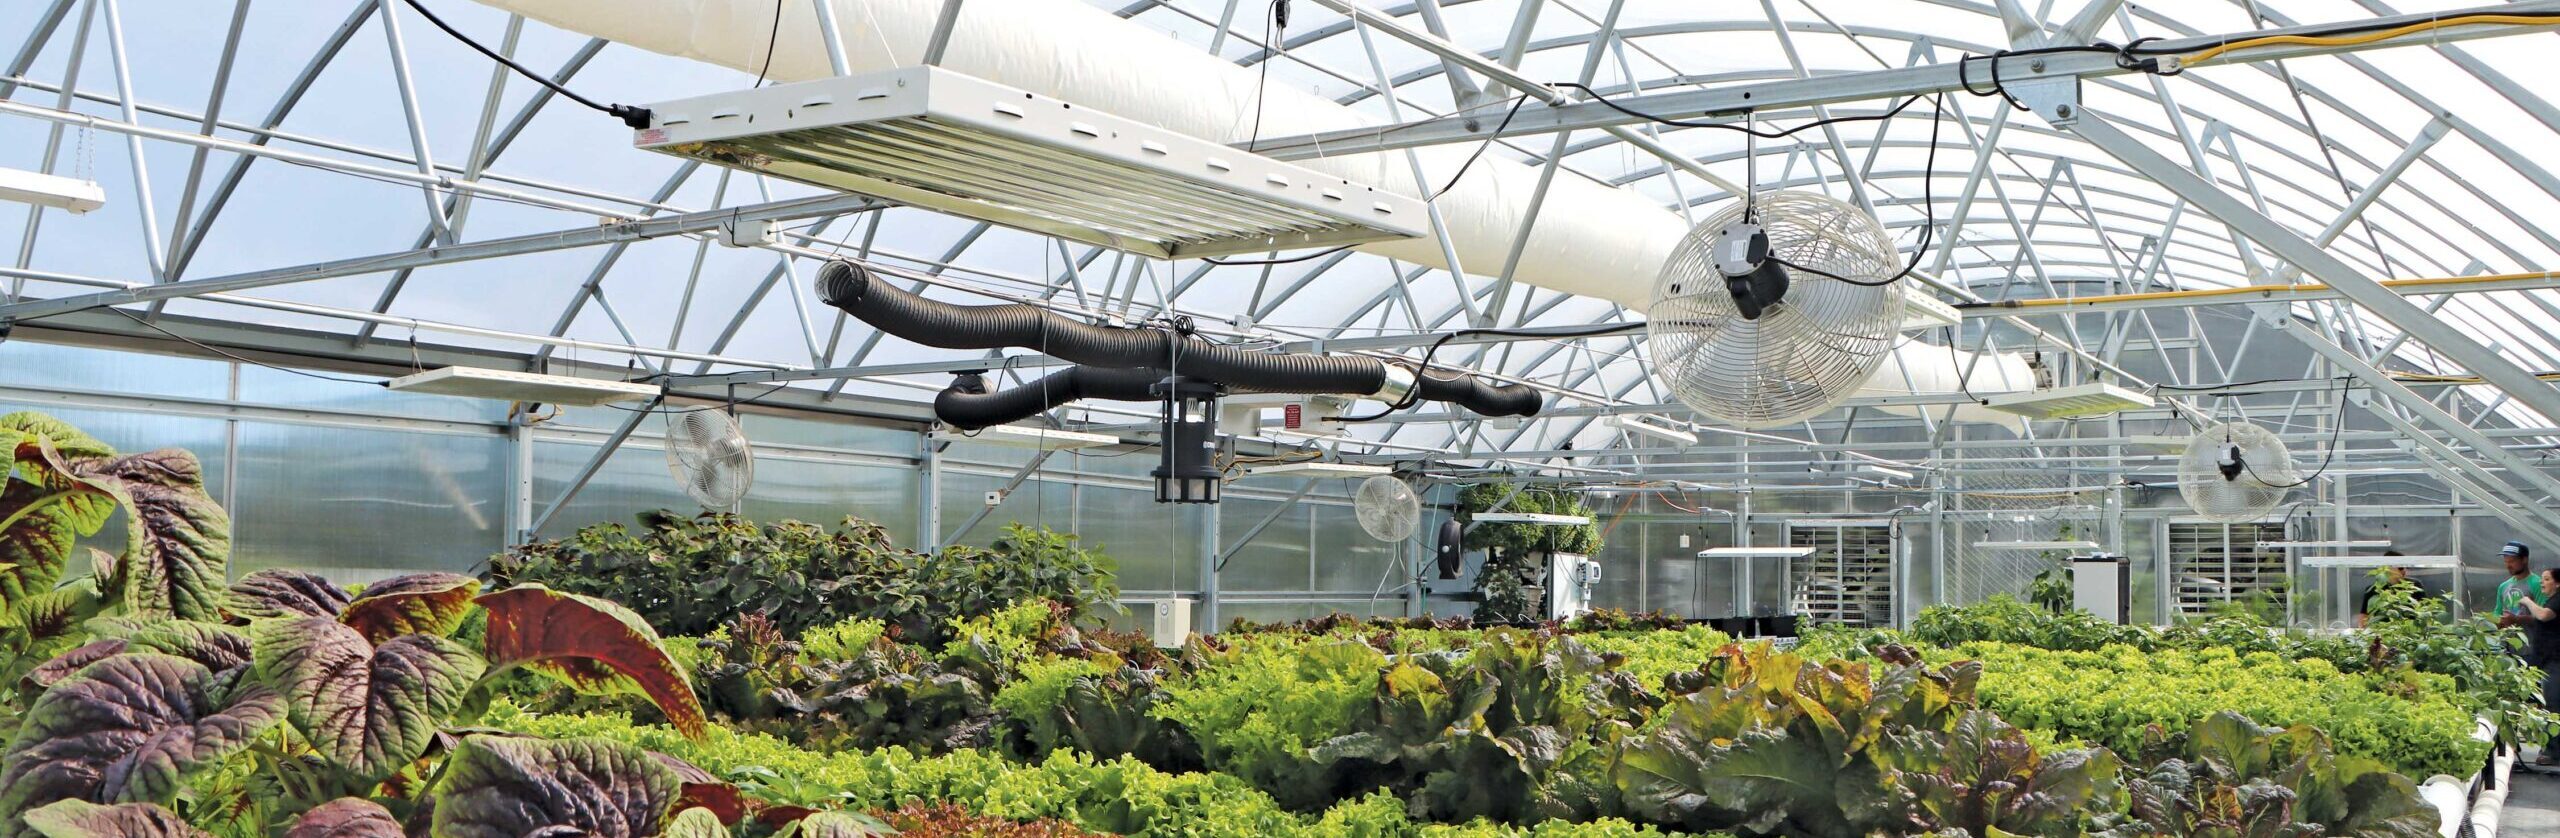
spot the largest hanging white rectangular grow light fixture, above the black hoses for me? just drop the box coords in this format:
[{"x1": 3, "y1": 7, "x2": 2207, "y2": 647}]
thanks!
[{"x1": 635, "y1": 67, "x2": 1423, "y2": 259}]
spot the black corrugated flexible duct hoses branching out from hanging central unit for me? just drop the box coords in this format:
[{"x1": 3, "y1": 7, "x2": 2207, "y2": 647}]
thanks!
[{"x1": 817, "y1": 259, "x2": 1541, "y2": 428}]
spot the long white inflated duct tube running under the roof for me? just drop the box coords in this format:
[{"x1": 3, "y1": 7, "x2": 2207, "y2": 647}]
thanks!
[{"x1": 479, "y1": 0, "x2": 2033, "y2": 423}]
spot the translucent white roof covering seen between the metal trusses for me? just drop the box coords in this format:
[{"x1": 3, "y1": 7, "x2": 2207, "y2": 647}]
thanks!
[{"x1": 0, "y1": 0, "x2": 2560, "y2": 466}]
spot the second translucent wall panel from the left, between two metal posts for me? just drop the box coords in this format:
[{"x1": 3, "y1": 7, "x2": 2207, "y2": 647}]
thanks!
[{"x1": 230, "y1": 423, "x2": 507, "y2": 584}]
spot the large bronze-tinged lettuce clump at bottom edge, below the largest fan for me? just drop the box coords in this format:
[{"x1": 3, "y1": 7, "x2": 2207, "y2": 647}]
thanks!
[{"x1": 1613, "y1": 643, "x2": 2117, "y2": 835}]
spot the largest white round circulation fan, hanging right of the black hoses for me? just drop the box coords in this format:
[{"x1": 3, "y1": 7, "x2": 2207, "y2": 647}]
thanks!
[{"x1": 1646, "y1": 192, "x2": 1905, "y2": 428}]
